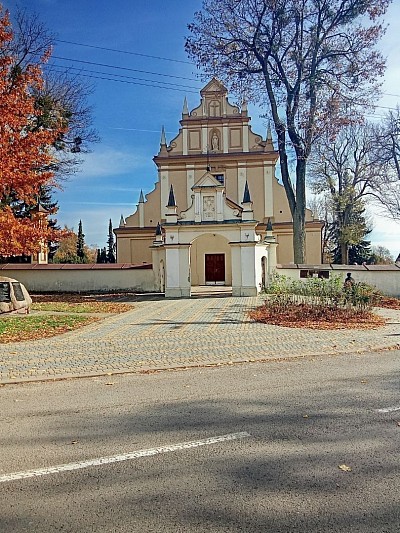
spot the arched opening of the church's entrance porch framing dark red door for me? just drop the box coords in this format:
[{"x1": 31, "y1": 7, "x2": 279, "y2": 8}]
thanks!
[{"x1": 190, "y1": 233, "x2": 232, "y2": 286}]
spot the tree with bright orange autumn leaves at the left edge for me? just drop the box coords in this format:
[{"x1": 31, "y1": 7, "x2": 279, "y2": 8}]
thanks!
[{"x1": 0, "y1": 5, "x2": 65, "y2": 256}]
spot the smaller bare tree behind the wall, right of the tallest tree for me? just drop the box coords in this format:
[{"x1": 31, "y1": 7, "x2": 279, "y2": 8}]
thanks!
[{"x1": 308, "y1": 124, "x2": 390, "y2": 263}]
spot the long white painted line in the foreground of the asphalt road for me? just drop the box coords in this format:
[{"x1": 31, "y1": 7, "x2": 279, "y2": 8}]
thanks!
[{"x1": 0, "y1": 431, "x2": 250, "y2": 483}]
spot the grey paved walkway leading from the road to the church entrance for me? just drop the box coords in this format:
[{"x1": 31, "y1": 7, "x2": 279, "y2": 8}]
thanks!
[{"x1": 0, "y1": 297, "x2": 400, "y2": 383}]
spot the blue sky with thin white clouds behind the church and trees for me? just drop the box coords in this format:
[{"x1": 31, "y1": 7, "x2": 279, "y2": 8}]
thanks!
[{"x1": 0, "y1": 0, "x2": 400, "y2": 256}]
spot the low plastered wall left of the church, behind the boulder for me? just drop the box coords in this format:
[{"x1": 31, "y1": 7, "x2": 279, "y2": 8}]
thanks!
[{"x1": 0, "y1": 263, "x2": 157, "y2": 292}]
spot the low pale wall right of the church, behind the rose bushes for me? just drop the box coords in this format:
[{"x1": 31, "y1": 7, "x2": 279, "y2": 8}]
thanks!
[{"x1": 276, "y1": 264, "x2": 400, "y2": 297}]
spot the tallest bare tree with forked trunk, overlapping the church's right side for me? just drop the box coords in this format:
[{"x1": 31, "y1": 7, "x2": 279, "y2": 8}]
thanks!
[{"x1": 186, "y1": 0, "x2": 390, "y2": 263}]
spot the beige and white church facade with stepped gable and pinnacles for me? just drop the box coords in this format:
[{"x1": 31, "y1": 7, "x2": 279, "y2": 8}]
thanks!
[{"x1": 114, "y1": 79, "x2": 322, "y2": 297}]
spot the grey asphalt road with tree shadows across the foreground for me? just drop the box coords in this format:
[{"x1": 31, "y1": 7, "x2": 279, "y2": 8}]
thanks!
[{"x1": 0, "y1": 351, "x2": 400, "y2": 533}]
